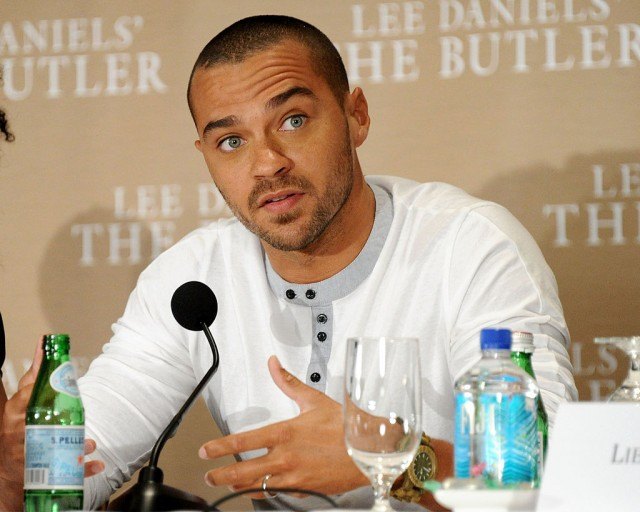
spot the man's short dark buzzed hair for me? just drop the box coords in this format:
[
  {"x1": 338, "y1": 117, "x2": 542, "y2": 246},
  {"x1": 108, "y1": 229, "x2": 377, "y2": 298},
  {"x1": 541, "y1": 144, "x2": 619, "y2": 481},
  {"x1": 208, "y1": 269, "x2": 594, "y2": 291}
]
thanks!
[{"x1": 187, "y1": 15, "x2": 349, "y2": 116}]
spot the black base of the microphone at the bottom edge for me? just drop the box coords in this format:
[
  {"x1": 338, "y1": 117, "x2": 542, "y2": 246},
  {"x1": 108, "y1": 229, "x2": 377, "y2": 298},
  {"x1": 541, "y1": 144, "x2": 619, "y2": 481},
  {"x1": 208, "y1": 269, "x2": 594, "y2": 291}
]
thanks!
[{"x1": 108, "y1": 467, "x2": 207, "y2": 512}]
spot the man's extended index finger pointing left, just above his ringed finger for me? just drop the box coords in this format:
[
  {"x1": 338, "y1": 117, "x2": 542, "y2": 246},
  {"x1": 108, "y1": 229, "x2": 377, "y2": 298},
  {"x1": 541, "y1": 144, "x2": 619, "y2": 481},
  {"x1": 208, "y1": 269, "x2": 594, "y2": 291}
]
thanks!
[{"x1": 198, "y1": 421, "x2": 290, "y2": 459}]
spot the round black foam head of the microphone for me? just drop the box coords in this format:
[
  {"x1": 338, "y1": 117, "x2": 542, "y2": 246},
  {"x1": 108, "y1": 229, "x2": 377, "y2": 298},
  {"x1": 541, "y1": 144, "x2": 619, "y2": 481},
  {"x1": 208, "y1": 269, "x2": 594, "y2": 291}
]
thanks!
[{"x1": 171, "y1": 281, "x2": 218, "y2": 331}]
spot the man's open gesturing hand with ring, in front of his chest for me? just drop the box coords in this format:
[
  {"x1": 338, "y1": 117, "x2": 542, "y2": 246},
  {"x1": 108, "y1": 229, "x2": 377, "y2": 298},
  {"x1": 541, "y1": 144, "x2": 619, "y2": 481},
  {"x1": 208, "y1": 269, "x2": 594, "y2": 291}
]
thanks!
[{"x1": 199, "y1": 356, "x2": 369, "y2": 499}]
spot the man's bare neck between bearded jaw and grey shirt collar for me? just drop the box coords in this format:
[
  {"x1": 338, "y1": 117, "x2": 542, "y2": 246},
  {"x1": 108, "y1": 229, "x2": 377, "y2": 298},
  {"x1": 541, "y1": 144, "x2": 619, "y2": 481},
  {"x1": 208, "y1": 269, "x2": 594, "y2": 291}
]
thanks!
[{"x1": 262, "y1": 177, "x2": 376, "y2": 284}]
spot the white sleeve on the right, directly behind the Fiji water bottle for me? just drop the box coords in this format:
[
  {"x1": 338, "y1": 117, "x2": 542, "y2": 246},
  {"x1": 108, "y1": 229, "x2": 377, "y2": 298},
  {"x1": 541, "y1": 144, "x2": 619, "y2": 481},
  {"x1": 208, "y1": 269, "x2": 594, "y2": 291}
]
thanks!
[{"x1": 449, "y1": 203, "x2": 577, "y2": 426}]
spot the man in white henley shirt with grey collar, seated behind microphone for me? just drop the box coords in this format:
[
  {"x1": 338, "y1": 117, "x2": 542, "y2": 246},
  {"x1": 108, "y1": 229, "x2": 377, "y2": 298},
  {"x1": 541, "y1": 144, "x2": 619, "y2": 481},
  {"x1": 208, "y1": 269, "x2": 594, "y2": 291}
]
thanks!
[{"x1": 2, "y1": 16, "x2": 575, "y2": 508}]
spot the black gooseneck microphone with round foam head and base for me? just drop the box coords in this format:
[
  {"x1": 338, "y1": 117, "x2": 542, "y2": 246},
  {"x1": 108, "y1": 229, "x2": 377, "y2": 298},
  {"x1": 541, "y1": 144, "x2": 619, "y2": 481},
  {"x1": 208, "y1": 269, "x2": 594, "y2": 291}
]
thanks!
[{"x1": 109, "y1": 281, "x2": 220, "y2": 512}]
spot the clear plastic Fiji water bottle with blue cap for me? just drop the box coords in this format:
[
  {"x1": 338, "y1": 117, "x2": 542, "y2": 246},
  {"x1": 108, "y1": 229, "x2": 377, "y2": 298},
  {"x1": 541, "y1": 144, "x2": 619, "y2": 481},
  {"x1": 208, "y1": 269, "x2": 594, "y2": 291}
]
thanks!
[{"x1": 454, "y1": 329, "x2": 540, "y2": 487}]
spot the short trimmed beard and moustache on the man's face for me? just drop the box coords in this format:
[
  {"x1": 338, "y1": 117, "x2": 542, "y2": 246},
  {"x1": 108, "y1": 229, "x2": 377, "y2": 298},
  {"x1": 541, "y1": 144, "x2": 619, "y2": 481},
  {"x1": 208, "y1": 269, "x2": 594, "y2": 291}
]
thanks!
[{"x1": 218, "y1": 123, "x2": 353, "y2": 251}]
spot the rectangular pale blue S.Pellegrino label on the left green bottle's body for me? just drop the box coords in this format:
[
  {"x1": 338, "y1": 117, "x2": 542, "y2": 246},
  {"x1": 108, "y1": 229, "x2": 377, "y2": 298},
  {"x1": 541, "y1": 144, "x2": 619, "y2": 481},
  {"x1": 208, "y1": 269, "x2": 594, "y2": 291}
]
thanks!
[{"x1": 24, "y1": 425, "x2": 84, "y2": 490}]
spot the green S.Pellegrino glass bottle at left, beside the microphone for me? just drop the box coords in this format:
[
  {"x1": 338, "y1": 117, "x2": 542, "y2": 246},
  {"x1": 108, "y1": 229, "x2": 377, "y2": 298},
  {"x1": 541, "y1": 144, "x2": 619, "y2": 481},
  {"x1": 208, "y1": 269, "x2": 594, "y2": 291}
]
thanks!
[{"x1": 24, "y1": 334, "x2": 84, "y2": 512}]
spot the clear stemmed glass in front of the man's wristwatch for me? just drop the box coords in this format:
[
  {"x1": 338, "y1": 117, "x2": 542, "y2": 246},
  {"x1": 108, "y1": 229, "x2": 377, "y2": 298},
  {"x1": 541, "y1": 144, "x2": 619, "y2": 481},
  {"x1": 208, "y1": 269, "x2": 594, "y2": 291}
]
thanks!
[{"x1": 344, "y1": 337, "x2": 422, "y2": 512}]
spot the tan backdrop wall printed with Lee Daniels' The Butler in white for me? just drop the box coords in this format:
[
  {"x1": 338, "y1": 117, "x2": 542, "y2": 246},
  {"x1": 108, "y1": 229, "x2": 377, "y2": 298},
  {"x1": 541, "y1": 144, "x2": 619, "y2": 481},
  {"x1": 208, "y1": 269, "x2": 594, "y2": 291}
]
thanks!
[{"x1": 0, "y1": 0, "x2": 640, "y2": 506}]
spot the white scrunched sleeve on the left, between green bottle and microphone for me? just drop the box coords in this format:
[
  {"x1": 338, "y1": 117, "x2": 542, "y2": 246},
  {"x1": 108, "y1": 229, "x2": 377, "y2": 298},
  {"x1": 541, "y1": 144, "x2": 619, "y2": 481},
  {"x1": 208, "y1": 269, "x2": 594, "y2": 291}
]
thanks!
[{"x1": 79, "y1": 268, "x2": 196, "y2": 508}]
